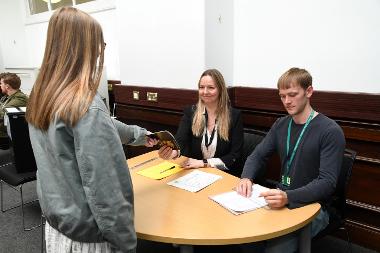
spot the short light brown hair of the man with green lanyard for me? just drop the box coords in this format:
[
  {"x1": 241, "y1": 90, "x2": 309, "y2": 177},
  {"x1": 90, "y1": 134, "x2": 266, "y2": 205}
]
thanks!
[{"x1": 277, "y1": 68, "x2": 313, "y2": 90}]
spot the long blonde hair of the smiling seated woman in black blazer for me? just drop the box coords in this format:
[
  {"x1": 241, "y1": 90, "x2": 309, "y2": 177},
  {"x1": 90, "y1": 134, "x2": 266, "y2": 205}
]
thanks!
[{"x1": 191, "y1": 69, "x2": 230, "y2": 141}]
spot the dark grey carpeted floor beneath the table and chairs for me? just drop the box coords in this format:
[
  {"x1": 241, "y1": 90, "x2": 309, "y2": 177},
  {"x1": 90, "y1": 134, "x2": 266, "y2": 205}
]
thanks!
[{"x1": 0, "y1": 182, "x2": 376, "y2": 253}]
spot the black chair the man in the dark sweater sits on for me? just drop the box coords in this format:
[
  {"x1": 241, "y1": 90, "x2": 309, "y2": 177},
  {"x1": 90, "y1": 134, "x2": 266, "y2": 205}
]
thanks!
[{"x1": 313, "y1": 149, "x2": 356, "y2": 252}]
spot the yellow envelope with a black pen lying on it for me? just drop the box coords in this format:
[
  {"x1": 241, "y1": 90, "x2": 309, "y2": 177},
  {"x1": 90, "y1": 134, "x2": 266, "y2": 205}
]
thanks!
[{"x1": 137, "y1": 161, "x2": 183, "y2": 179}]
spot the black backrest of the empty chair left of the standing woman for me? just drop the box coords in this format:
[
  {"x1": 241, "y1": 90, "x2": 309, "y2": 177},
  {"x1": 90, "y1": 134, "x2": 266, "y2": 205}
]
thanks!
[{"x1": 7, "y1": 109, "x2": 37, "y2": 173}]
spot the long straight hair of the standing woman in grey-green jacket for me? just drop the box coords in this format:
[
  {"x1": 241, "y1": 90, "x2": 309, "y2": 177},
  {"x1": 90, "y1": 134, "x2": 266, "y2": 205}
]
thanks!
[{"x1": 26, "y1": 7, "x2": 104, "y2": 130}]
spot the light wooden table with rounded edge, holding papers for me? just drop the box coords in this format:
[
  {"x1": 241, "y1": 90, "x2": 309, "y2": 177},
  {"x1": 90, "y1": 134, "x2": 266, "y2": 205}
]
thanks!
[{"x1": 128, "y1": 151, "x2": 320, "y2": 252}]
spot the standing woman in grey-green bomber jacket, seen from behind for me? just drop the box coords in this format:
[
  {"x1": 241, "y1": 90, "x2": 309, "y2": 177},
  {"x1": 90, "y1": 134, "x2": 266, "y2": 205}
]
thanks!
[{"x1": 26, "y1": 7, "x2": 155, "y2": 253}]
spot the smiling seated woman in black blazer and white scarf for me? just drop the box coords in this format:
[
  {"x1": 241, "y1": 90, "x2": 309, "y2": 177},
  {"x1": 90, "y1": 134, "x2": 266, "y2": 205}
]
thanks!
[{"x1": 159, "y1": 69, "x2": 243, "y2": 176}]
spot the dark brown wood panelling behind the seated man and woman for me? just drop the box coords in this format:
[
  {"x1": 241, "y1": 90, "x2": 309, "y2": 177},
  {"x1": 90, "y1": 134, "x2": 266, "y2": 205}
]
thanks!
[{"x1": 113, "y1": 85, "x2": 380, "y2": 251}]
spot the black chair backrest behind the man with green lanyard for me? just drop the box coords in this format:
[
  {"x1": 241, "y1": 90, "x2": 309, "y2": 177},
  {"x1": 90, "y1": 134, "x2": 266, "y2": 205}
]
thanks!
[{"x1": 331, "y1": 149, "x2": 356, "y2": 220}]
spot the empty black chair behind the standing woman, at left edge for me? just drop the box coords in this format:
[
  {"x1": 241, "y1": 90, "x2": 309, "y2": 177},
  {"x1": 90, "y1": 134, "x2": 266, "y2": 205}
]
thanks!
[{"x1": 0, "y1": 107, "x2": 41, "y2": 231}]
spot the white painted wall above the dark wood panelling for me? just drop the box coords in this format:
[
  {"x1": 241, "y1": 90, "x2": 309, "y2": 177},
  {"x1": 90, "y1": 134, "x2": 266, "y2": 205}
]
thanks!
[{"x1": 0, "y1": 0, "x2": 380, "y2": 93}]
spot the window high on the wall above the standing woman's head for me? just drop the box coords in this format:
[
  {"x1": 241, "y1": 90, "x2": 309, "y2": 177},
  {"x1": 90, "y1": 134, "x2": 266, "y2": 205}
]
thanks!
[{"x1": 28, "y1": 0, "x2": 95, "y2": 15}]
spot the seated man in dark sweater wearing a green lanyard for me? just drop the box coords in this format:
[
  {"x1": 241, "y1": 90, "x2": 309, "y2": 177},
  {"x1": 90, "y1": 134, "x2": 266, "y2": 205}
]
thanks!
[{"x1": 237, "y1": 68, "x2": 345, "y2": 252}]
